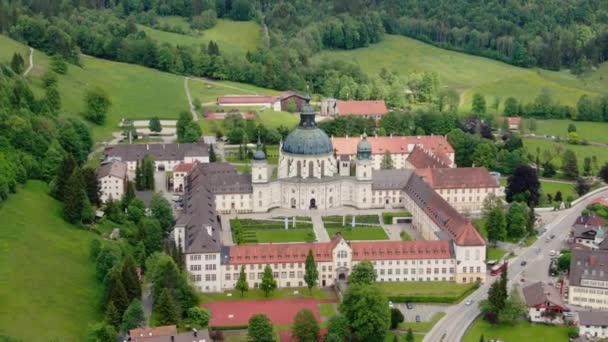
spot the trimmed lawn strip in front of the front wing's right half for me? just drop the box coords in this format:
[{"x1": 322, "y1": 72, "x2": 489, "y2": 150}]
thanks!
[{"x1": 376, "y1": 281, "x2": 476, "y2": 298}]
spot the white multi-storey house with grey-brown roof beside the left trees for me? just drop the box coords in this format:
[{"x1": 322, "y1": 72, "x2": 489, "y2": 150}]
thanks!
[{"x1": 97, "y1": 160, "x2": 128, "y2": 203}]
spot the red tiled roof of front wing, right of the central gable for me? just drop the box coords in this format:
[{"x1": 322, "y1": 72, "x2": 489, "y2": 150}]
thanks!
[{"x1": 350, "y1": 240, "x2": 452, "y2": 260}]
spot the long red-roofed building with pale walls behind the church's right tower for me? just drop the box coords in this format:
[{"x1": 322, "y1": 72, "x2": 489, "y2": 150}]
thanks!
[{"x1": 331, "y1": 135, "x2": 456, "y2": 170}]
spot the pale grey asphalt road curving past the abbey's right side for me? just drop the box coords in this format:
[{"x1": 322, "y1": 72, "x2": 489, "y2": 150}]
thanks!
[{"x1": 423, "y1": 190, "x2": 608, "y2": 342}]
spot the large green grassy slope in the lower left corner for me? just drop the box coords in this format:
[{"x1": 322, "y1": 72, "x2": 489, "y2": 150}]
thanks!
[{"x1": 0, "y1": 182, "x2": 102, "y2": 341}]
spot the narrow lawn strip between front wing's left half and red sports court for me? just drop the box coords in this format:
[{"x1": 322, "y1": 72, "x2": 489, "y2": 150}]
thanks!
[{"x1": 199, "y1": 287, "x2": 333, "y2": 303}]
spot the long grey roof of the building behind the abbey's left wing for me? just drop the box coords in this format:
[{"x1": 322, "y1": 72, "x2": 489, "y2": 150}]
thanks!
[{"x1": 104, "y1": 141, "x2": 209, "y2": 161}]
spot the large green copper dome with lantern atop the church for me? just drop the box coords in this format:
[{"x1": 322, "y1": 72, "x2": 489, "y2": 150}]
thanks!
[{"x1": 282, "y1": 98, "x2": 334, "y2": 155}]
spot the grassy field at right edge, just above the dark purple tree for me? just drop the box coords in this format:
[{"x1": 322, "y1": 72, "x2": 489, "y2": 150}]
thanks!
[{"x1": 523, "y1": 138, "x2": 608, "y2": 172}]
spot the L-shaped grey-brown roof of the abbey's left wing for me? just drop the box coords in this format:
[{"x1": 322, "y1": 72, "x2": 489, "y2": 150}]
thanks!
[{"x1": 176, "y1": 163, "x2": 252, "y2": 253}]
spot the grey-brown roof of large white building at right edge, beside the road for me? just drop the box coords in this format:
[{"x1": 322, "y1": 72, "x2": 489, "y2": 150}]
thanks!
[{"x1": 570, "y1": 249, "x2": 608, "y2": 286}]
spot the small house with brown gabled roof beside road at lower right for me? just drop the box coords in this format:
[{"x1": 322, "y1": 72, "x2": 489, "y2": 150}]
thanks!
[{"x1": 522, "y1": 282, "x2": 567, "y2": 323}]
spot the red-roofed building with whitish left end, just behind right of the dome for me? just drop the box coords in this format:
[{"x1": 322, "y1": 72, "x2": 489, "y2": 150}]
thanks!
[{"x1": 321, "y1": 99, "x2": 388, "y2": 120}]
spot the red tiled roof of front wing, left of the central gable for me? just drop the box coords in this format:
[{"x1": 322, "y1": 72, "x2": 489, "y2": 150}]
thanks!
[{"x1": 230, "y1": 234, "x2": 342, "y2": 265}]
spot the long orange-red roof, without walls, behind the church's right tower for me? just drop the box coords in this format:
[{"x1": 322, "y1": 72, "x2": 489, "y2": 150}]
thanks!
[{"x1": 332, "y1": 135, "x2": 454, "y2": 155}]
